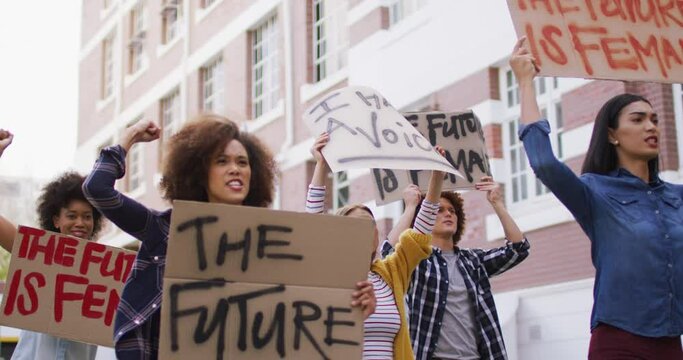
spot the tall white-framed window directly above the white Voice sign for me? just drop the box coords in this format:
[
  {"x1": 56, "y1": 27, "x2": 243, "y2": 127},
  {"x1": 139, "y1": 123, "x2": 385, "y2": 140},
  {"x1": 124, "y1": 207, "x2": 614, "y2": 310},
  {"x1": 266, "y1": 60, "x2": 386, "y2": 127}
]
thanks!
[{"x1": 312, "y1": 0, "x2": 349, "y2": 82}]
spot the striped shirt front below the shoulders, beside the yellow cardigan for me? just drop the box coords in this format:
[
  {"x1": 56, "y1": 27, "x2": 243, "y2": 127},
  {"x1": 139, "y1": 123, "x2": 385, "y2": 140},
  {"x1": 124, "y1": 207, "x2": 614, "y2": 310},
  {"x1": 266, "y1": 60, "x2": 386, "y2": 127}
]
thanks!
[{"x1": 363, "y1": 273, "x2": 401, "y2": 360}]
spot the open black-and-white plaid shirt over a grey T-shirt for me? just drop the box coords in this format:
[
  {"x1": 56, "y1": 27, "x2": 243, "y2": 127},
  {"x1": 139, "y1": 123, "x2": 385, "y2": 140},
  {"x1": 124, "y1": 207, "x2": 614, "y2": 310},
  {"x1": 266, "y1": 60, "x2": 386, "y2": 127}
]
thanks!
[{"x1": 382, "y1": 239, "x2": 529, "y2": 360}]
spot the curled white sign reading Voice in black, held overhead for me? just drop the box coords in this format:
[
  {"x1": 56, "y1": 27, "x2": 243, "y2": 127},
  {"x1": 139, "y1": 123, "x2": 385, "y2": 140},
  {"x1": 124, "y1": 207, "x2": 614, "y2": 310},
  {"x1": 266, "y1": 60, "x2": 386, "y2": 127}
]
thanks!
[{"x1": 304, "y1": 87, "x2": 461, "y2": 176}]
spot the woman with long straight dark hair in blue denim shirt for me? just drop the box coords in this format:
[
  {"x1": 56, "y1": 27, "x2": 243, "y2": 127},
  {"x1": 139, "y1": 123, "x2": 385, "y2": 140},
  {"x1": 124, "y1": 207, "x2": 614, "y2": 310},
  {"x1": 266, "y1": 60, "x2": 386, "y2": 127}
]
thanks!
[{"x1": 510, "y1": 38, "x2": 683, "y2": 359}]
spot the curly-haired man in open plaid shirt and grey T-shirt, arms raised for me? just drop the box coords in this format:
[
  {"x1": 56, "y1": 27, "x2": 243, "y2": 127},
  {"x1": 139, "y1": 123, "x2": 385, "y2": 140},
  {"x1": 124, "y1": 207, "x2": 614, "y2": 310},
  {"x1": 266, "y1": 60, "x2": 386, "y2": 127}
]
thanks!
[{"x1": 381, "y1": 176, "x2": 529, "y2": 360}]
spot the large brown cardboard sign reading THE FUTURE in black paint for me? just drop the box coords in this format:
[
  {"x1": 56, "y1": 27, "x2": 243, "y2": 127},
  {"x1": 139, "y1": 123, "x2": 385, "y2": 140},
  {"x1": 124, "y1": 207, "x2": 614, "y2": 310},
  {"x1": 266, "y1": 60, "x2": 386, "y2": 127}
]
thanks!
[{"x1": 159, "y1": 201, "x2": 374, "y2": 359}]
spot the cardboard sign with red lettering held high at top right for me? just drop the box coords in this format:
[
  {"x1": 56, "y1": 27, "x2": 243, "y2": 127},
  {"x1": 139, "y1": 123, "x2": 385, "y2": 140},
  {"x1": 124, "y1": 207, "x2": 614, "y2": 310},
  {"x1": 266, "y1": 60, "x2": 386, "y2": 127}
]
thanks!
[{"x1": 508, "y1": 0, "x2": 683, "y2": 83}]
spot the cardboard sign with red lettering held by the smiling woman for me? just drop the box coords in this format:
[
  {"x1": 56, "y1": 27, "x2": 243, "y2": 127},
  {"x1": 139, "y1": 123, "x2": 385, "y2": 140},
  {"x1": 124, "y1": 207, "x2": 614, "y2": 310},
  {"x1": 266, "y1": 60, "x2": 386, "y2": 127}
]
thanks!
[{"x1": 0, "y1": 226, "x2": 135, "y2": 347}]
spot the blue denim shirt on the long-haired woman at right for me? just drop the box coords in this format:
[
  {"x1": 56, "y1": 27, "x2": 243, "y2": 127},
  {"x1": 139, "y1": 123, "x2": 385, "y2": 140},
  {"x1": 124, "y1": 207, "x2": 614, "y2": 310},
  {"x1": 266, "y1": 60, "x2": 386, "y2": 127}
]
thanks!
[{"x1": 519, "y1": 120, "x2": 683, "y2": 337}]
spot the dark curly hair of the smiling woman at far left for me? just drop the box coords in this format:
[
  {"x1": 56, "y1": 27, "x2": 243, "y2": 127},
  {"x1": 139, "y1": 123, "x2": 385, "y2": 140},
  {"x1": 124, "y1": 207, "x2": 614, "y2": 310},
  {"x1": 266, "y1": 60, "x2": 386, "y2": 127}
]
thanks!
[{"x1": 37, "y1": 171, "x2": 103, "y2": 238}]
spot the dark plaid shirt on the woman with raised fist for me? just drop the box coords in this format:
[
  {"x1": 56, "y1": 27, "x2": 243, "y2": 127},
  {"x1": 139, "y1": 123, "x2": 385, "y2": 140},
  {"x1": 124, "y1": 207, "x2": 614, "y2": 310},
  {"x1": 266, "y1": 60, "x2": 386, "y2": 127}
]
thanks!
[{"x1": 83, "y1": 146, "x2": 171, "y2": 359}]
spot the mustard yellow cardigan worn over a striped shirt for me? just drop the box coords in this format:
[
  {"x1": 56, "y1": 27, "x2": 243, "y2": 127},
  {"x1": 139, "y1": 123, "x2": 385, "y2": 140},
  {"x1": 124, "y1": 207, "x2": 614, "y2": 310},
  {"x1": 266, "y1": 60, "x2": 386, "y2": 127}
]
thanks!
[{"x1": 370, "y1": 229, "x2": 432, "y2": 360}]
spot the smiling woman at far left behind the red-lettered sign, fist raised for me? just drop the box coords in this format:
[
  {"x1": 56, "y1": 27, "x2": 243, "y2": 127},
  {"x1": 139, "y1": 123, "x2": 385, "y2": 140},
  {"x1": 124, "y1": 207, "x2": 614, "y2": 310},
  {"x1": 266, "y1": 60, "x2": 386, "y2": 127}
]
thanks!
[{"x1": 0, "y1": 129, "x2": 103, "y2": 360}]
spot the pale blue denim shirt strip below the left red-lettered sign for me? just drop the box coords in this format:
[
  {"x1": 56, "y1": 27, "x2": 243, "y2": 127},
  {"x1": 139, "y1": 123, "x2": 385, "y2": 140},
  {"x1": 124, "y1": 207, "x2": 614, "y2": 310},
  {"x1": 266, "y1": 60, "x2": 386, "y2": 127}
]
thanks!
[{"x1": 12, "y1": 330, "x2": 97, "y2": 360}]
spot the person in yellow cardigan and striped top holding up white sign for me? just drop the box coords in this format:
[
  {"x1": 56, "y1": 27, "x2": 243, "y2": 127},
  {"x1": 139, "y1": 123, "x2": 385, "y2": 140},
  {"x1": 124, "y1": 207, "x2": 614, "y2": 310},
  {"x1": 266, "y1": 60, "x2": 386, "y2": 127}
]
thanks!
[{"x1": 306, "y1": 133, "x2": 444, "y2": 359}]
